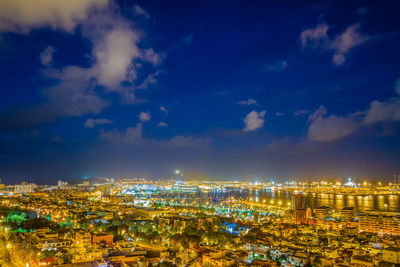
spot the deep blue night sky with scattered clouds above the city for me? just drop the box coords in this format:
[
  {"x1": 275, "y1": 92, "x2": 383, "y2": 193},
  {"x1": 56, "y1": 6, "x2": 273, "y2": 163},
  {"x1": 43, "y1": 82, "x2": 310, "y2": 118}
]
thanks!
[{"x1": 0, "y1": 0, "x2": 400, "y2": 183}]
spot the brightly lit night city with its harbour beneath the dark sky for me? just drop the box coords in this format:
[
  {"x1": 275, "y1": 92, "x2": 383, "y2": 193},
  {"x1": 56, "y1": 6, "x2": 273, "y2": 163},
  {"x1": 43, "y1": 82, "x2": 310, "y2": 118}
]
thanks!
[{"x1": 0, "y1": 176, "x2": 400, "y2": 266}]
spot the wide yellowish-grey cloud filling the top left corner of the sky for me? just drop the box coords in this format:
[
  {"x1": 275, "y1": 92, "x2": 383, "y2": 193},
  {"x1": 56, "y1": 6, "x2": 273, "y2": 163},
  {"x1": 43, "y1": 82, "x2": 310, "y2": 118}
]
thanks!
[{"x1": 0, "y1": 0, "x2": 108, "y2": 33}]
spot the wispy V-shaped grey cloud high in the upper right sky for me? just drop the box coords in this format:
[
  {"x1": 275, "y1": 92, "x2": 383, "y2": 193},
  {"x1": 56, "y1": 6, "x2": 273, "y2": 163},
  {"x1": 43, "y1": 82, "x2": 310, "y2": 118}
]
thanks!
[{"x1": 300, "y1": 24, "x2": 369, "y2": 66}]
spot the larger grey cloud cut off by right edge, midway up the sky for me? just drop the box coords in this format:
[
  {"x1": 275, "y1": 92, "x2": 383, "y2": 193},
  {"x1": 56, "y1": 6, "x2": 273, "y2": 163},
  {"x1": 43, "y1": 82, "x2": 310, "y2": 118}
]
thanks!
[{"x1": 363, "y1": 98, "x2": 400, "y2": 125}]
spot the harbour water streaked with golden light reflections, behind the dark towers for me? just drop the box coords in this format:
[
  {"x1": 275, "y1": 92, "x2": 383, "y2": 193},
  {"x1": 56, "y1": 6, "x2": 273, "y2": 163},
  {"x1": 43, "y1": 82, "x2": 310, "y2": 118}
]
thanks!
[{"x1": 200, "y1": 190, "x2": 400, "y2": 214}]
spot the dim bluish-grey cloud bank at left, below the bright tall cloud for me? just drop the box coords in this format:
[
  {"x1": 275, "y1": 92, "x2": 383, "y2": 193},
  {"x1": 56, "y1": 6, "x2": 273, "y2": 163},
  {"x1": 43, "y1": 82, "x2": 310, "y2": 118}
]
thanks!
[{"x1": 1, "y1": 66, "x2": 109, "y2": 129}]
